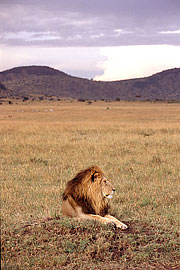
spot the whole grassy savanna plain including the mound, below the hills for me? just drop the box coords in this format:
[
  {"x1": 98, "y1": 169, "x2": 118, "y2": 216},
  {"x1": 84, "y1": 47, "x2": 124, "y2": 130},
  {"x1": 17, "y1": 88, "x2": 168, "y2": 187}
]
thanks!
[{"x1": 0, "y1": 101, "x2": 180, "y2": 270}]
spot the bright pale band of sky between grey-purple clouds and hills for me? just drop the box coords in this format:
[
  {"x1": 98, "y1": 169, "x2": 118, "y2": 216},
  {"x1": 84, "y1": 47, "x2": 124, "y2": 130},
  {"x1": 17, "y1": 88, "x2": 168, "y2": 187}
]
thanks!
[{"x1": 0, "y1": 45, "x2": 180, "y2": 81}]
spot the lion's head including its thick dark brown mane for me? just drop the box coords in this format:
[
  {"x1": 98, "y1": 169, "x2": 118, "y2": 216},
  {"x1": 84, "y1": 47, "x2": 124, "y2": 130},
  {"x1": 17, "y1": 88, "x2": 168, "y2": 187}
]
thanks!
[{"x1": 63, "y1": 166, "x2": 115, "y2": 216}]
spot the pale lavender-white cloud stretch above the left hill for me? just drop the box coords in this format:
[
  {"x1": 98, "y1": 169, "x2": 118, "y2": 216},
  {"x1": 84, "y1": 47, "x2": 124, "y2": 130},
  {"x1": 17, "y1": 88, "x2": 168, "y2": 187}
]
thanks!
[{"x1": 0, "y1": 46, "x2": 105, "y2": 79}]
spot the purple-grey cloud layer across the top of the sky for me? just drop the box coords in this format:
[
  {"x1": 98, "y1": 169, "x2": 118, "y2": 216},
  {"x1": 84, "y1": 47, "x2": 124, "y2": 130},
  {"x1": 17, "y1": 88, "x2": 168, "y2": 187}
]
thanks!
[{"x1": 0, "y1": 0, "x2": 180, "y2": 47}]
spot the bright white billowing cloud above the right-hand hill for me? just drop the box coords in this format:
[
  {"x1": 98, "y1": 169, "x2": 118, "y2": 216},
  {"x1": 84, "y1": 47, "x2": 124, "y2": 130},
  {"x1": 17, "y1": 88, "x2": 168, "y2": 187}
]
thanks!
[{"x1": 94, "y1": 45, "x2": 180, "y2": 81}]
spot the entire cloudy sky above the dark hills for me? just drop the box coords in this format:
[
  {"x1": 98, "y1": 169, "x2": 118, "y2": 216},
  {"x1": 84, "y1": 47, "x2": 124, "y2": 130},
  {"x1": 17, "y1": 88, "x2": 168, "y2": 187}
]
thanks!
[{"x1": 0, "y1": 0, "x2": 180, "y2": 81}]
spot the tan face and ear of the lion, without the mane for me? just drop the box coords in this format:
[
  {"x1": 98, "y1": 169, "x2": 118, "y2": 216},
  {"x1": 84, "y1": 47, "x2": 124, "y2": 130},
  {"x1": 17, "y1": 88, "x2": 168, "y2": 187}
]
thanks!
[{"x1": 93, "y1": 172, "x2": 115, "y2": 199}]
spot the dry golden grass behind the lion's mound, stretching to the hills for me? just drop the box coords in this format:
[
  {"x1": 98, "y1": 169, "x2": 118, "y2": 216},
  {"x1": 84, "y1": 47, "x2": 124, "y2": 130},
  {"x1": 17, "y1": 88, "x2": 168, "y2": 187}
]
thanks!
[{"x1": 0, "y1": 102, "x2": 180, "y2": 269}]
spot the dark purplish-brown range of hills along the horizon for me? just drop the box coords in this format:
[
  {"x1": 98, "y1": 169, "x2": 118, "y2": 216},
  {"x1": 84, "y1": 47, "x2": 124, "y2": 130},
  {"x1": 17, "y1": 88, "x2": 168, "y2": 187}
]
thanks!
[{"x1": 0, "y1": 66, "x2": 180, "y2": 100}]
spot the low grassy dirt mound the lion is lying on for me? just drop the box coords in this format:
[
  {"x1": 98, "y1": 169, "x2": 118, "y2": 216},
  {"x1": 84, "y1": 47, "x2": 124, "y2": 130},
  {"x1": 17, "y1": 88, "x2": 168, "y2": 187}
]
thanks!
[{"x1": 2, "y1": 218, "x2": 180, "y2": 270}]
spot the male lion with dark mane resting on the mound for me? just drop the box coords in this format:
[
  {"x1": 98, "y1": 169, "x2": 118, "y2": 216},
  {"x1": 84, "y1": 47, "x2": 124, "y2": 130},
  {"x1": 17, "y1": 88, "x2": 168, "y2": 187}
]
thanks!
[{"x1": 62, "y1": 166, "x2": 128, "y2": 230}]
